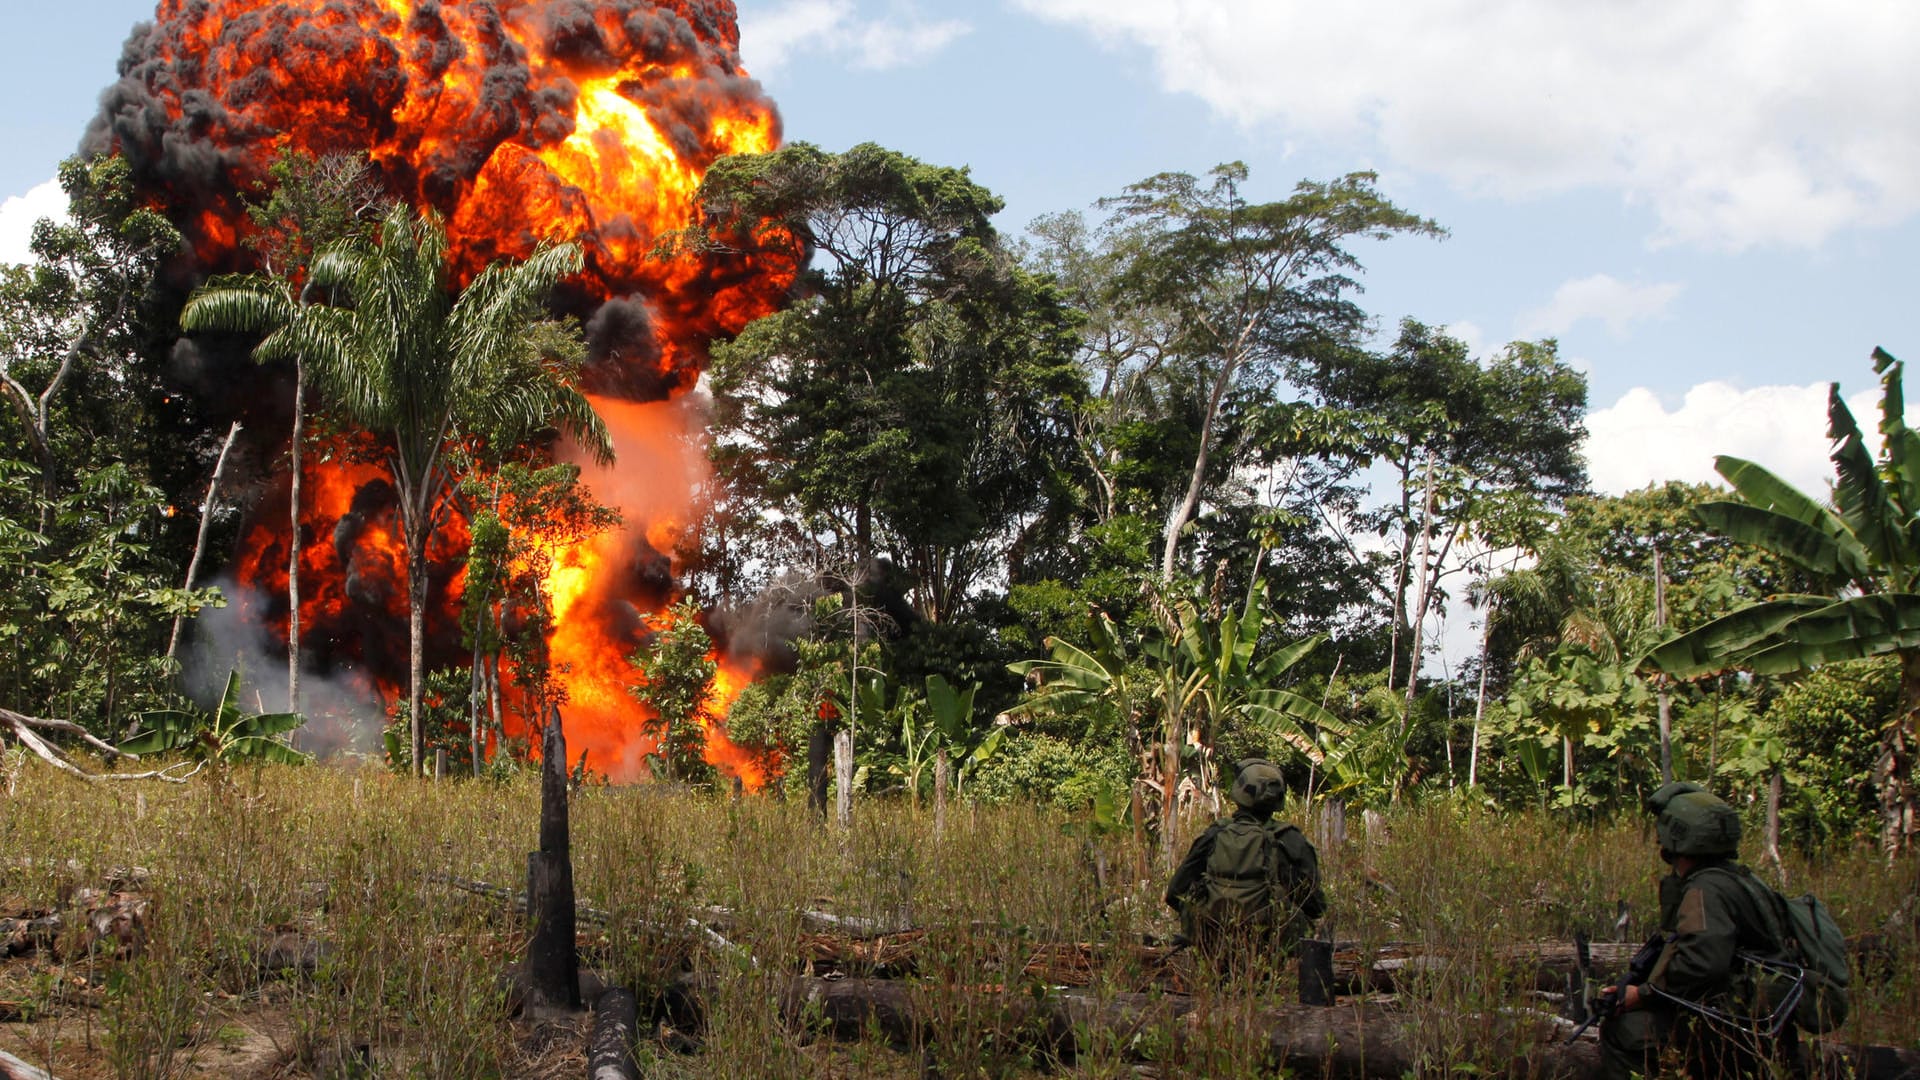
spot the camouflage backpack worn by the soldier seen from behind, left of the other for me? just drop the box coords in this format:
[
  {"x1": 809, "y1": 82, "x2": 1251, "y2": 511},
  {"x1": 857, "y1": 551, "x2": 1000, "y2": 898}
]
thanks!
[{"x1": 1200, "y1": 817, "x2": 1319, "y2": 944}]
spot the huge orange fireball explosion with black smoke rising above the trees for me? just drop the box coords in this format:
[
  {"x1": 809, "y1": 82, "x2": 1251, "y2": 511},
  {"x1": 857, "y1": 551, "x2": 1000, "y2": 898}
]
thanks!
[{"x1": 83, "y1": 0, "x2": 797, "y2": 786}]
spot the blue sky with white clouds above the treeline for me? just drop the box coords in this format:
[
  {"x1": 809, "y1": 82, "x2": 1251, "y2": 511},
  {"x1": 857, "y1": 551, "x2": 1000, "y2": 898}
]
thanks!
[{"x1": 0, "y1": 0, "x2": 1920, "y2": 490}]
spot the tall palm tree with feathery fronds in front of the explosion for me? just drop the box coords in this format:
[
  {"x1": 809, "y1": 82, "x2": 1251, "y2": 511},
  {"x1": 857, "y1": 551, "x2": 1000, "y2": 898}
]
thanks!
[{"x1": 303, "y1": 206, "x2": 612, "y2": 773}]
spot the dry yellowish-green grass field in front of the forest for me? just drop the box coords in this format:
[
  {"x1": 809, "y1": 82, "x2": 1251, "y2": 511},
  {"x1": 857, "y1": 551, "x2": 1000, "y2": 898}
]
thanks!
[{"x1": 0, "y1": 763, "x2": 1920, "y2": 1078}]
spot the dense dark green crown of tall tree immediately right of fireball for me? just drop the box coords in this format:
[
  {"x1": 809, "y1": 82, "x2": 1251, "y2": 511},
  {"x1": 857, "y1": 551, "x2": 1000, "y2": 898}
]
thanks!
[{"x1": 697, "y1": 144, "x2": 1081, "y2": 621}]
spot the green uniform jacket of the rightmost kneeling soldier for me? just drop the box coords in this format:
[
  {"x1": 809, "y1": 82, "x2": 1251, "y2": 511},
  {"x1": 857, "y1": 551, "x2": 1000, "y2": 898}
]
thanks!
[{"x1": 1647, "y1": 861, "x2": 1786, "y2": 1001}]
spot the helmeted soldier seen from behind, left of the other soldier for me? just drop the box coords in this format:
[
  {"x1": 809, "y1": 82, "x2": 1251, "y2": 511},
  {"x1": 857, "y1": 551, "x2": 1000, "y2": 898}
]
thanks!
[{"x1": 1165, "y1": 757, "x2": 1327, "y2": 969}]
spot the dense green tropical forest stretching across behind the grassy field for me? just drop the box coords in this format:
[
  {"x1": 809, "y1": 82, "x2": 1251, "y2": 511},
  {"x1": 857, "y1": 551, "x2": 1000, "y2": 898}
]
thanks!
[{"x1": 0, "y1": 136, "x2": 1920, "y2": 864}]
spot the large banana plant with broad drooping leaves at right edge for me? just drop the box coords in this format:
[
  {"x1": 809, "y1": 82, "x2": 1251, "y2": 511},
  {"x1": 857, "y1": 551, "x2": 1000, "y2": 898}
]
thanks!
[{"x1": 1647, "y1": 348, "x2": 1920, "y2": 857}]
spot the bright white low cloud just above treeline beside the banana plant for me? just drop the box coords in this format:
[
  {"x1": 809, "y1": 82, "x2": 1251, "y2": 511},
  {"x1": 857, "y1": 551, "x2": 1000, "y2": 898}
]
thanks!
[{"x1": 1586, "y1": 382, "x2": 1880, "y2": 496}]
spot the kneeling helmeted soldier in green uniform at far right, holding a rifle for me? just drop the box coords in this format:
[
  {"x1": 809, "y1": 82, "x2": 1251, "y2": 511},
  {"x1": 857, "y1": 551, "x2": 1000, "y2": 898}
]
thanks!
[{"x1": 1599, "y1": 782, "x2": 1797, "y2": 1078}]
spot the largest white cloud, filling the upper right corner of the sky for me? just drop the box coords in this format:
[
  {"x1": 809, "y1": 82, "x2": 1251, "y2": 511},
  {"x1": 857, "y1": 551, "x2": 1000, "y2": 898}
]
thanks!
[{"x1": 1014, "y1": 0, "x2": 1920, "y2": 250}]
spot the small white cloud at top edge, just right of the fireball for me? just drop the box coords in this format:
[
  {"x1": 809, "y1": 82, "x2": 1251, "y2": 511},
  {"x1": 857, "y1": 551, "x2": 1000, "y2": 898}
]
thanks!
[{"x1": 739, "y1": 0, "x2": 972, "y2": 75}]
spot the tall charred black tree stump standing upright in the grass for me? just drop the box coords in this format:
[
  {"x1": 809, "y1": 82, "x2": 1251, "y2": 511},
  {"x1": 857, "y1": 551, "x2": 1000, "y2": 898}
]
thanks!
[{"x1": 526, "y1": 709, "x2": 580, "y2": 1011}]
